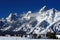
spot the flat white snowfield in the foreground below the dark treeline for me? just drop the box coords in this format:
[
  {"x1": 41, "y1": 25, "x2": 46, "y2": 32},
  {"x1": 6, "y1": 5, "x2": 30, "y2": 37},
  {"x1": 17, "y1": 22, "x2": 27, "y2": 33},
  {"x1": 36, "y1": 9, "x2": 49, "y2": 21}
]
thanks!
[{"x1": 0, "y1": 36, "x2": 60, "y2": 40}]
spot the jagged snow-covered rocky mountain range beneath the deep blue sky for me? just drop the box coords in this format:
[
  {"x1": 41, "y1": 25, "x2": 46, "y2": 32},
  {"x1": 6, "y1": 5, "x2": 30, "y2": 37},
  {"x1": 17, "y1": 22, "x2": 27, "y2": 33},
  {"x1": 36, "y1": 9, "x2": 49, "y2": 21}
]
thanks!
[{"x1": 0, "y1": 6, "x2": 60, "y2": 34}]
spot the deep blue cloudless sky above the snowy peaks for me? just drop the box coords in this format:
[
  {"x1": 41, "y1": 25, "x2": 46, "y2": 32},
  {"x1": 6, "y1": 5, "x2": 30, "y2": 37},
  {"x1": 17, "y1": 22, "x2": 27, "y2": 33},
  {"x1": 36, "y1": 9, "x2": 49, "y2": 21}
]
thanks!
[{"x1": 0, "y1": 0, "x2": 60, "y2": 18}]
